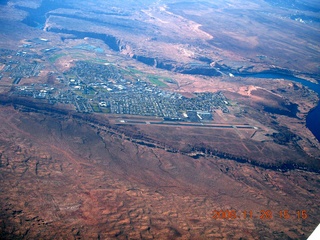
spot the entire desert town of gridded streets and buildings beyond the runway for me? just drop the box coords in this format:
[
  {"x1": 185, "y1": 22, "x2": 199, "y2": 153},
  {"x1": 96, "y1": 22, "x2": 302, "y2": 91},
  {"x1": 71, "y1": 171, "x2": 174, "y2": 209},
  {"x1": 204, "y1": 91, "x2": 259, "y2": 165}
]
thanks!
[{"x1": 0, "y1": 50, "x2": 229, "y2": 122}]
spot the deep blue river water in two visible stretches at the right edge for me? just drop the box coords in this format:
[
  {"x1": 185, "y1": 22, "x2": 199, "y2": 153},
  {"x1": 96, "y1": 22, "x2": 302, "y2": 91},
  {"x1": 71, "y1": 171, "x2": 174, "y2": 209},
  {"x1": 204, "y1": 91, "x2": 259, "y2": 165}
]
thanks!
[{"x1": 235, "y1": 73, "x2": 320, "y2": 142}]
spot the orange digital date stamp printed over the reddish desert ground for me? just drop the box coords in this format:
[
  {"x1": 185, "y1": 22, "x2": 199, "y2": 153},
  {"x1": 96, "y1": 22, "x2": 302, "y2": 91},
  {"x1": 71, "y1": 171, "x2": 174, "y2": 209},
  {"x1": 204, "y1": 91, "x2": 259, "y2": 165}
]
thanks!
[{"x1": 212, "y1": 210, "x2": 308, "y2": 220}]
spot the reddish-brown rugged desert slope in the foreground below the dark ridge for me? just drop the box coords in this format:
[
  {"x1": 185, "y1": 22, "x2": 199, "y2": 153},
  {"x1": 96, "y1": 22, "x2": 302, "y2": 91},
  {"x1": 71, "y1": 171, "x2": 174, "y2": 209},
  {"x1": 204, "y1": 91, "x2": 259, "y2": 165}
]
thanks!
[{"x1": 0, "y1": 106, "x2": 320, "y2": 239}]
